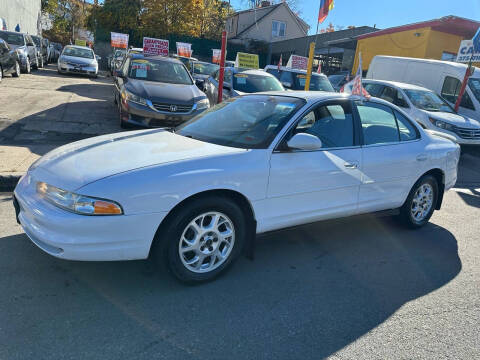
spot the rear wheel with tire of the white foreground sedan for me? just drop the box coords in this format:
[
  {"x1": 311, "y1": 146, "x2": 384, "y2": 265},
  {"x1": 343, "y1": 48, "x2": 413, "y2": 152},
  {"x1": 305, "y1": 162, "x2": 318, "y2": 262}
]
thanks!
[{"x1": 400, "y1": 175, "x2": 438, "y2": 229}]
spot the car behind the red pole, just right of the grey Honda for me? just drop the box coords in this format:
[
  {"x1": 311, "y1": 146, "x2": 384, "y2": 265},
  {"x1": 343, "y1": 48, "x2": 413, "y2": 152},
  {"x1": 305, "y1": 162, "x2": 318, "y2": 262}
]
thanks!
[{"x1": 205, "y1": 68, "x2": 285, "y2": 104}]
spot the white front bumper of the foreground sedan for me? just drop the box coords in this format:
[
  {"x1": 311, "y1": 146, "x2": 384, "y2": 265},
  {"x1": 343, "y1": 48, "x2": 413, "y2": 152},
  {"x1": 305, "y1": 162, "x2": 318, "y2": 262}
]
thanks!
[{"x1": 14, "y1": 173, "x2": 166, "y2": 261}]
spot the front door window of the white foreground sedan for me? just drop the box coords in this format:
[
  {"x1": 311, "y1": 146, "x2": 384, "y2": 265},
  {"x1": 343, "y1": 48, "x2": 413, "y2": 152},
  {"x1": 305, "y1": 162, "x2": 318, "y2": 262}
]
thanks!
[{"x1": 292, "y1": 103, "x2": 354, "y2": 149}]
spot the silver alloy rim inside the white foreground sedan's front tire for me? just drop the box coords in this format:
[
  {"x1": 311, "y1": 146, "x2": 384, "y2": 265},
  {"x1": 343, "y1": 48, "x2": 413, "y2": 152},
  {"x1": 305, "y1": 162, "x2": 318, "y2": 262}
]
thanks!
[{"x1": 178, "y1": 211, "x2": 235, "y2": 273}]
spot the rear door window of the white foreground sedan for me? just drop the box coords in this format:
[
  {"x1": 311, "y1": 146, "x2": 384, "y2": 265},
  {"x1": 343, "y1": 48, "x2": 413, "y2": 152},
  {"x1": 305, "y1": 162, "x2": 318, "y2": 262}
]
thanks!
[{"x1": 356, "y1": 102, "x2": 400, "y2": 145}]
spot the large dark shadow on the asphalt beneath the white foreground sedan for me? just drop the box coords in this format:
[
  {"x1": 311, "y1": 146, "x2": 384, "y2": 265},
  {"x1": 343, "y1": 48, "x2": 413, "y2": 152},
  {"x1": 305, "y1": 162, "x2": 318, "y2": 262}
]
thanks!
[{"x1": 0, "y1": 216, "x2": 462, "y2": 359}]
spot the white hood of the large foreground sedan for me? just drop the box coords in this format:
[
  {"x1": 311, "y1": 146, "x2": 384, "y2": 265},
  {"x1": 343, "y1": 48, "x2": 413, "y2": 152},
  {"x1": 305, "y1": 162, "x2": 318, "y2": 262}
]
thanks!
[{"x1": 29, "y1": 129, "x2": 245, "y2": 191}]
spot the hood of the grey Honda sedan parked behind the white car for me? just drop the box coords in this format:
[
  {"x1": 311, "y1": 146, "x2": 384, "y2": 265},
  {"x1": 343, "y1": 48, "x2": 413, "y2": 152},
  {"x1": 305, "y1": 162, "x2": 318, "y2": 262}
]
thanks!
[{"x1": 125, "y1": 79, "x2": 205, "y2": 105}]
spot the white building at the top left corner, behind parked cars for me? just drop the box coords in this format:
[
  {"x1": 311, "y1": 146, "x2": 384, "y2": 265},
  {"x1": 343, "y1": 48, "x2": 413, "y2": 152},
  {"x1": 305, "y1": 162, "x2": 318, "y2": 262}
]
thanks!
[{"x1": 0, "y1": 0, "x2": 42, "y2": 35}]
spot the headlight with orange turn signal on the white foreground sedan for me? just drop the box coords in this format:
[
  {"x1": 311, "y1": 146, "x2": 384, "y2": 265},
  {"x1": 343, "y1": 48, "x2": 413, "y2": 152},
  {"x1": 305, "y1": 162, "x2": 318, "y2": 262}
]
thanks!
[{"x1": 37, "y1": 182, "x2": 123, "y2": 215}]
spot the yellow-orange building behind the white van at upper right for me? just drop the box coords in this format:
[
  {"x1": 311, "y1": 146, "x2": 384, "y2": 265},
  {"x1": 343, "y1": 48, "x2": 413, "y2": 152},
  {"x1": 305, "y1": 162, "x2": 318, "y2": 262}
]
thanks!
[{"x1": 354, "y1": 16, "x2": 480, "y2": 71}]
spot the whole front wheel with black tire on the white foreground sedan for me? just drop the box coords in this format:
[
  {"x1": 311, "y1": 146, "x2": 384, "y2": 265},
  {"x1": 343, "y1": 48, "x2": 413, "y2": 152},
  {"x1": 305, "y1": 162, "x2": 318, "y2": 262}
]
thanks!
[{"x1": 152, "y1": 196, "x2": 248, "y2": 284}]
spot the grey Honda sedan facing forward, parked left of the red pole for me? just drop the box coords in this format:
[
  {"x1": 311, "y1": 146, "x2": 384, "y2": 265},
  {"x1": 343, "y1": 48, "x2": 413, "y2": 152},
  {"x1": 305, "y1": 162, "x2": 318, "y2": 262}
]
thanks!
[{"x1": 114, "y1": 54, "x2": 210, "y2": 128}]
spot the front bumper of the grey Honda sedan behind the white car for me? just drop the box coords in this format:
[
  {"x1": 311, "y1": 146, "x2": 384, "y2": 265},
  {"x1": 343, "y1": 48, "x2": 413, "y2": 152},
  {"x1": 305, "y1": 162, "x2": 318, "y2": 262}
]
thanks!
[{"x1": 121, "y1": 101, "x2": 206, "y2": 127}]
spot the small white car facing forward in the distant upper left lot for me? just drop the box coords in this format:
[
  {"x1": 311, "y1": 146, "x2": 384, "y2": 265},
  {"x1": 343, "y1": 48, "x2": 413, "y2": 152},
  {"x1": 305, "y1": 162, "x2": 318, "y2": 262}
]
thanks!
[{"x1": 57, "y1": 45, "x2": 99, "y2": 77}]
